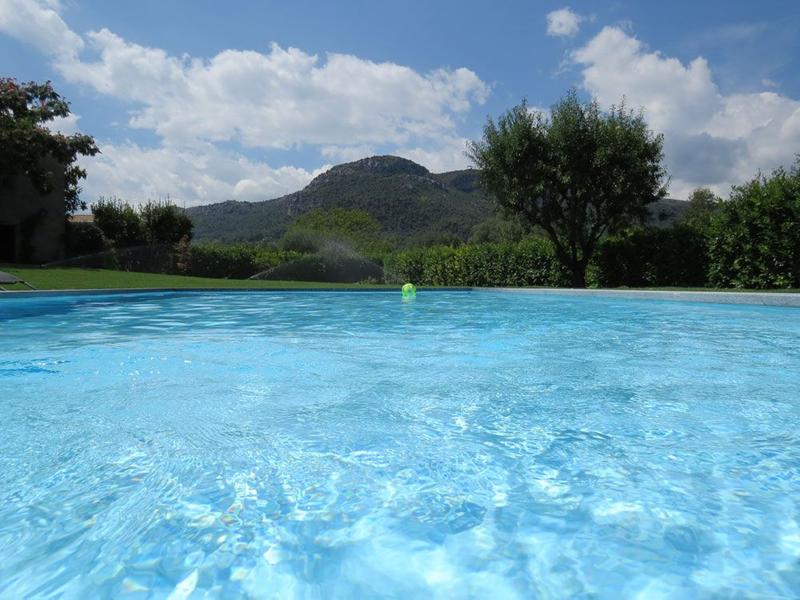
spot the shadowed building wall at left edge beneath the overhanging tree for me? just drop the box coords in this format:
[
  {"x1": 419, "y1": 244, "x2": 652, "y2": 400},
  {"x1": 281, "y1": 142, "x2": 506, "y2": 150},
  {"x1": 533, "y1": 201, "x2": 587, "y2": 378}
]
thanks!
[{"x1": 0, "y1": 160, "x2": 65, "y2": 263}]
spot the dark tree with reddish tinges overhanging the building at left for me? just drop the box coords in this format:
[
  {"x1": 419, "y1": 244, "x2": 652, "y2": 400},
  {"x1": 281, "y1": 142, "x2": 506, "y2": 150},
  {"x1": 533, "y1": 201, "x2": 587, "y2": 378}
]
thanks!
[{"x1": 0, "y1": 78, "x2": 99, "y2": 214}]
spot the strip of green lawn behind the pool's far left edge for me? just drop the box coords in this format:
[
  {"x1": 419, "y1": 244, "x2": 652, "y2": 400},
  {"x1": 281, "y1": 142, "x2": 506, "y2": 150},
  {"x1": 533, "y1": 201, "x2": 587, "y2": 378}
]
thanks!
[{"x1": 0, "y1": 265, "x2": 399, "y2": 290}]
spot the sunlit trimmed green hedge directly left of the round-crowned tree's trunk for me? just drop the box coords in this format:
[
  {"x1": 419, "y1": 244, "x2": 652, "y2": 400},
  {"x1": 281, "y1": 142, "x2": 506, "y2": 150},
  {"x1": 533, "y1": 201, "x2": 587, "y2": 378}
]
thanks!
[{"x1": 385, "y1": 238, "x2": 564, "y2": 287}]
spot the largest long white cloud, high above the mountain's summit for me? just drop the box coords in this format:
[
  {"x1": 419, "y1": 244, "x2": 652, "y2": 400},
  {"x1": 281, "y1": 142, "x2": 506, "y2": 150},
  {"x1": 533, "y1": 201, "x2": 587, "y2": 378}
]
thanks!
[{"x1": 57, "y1": 29, "x2": 488, "y2": 148}]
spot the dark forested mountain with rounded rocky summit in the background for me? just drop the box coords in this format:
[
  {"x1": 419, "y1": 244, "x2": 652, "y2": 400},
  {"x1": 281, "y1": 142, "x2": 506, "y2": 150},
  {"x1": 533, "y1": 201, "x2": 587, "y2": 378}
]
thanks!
[{"x1": 187, "y1": 156, "x2": 685, "y2": 242}]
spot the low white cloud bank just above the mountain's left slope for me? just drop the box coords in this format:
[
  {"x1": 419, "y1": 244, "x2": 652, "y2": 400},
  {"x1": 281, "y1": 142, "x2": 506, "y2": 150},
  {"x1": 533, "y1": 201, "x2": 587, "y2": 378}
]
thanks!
[{"x1": 81, "y1": 142, "x2": 329, "y2": 206}]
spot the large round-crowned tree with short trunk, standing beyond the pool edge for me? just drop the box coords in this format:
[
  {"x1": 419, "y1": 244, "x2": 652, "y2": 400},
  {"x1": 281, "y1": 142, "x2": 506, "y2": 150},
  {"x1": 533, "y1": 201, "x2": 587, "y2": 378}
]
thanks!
[{"x1": 468, "y1": 90, "x2": 666, "y2": 287}]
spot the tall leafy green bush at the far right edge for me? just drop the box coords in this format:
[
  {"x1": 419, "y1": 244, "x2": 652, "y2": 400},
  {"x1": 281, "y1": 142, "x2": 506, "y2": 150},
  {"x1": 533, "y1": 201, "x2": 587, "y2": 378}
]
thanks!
[{"x1": 709, "y1": 161, "x2": 800, "y2": 288}]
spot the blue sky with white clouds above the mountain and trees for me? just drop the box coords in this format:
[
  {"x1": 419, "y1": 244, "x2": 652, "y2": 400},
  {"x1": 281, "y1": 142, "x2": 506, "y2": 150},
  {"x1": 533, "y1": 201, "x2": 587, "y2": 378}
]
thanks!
[{"x1": 0, "y1": 0, "x2": 800, "y2": 206}]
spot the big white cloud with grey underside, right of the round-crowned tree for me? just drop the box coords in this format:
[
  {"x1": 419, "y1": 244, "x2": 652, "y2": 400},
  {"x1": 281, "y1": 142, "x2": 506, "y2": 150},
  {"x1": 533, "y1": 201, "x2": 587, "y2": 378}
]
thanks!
[{"x1": 572, "y1": 27, "x2": 800, "y2": 197}]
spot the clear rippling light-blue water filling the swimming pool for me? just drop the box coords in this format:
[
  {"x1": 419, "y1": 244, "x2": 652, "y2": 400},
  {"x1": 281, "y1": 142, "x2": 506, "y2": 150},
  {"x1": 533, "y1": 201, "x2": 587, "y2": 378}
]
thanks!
[{"x1": 0, "y1": 291, "x2": 800, "y2": 598}]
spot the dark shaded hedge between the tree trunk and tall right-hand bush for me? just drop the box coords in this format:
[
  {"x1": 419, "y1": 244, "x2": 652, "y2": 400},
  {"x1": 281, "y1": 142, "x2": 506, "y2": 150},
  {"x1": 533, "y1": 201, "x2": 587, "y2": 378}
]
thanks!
[{"x1": 592, "y1": 226, "x2": 708, "y2": 287}]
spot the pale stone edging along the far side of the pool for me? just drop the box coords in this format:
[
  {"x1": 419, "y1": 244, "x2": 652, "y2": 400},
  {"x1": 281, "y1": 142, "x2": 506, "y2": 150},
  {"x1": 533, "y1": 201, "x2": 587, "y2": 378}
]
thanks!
[{"x1": 0, "y1": 286, "x2": 800, "y2": 308}]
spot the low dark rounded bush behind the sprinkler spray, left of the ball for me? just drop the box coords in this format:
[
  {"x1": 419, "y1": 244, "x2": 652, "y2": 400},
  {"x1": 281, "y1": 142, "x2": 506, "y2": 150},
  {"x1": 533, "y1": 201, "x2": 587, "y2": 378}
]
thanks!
[{"x1": 254, "y1": 254, "x2": 383, "y2": 283}]
